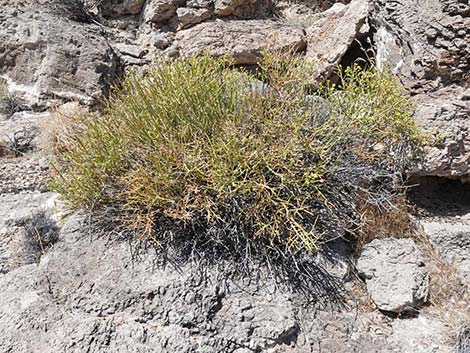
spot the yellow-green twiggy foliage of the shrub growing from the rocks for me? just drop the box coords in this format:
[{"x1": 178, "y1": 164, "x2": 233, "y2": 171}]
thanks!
[{"x1": 52, "y1": 54, "x2": 422, "y2": 251}]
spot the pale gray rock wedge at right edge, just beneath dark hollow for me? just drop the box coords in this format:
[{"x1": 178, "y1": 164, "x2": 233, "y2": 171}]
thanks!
[{"x1": 420, "y1": 219, "x2": 470, "y2": 283}]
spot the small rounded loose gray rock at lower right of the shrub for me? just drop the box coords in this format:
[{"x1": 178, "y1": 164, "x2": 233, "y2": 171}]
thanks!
[{"x1": 357, "y1": 238, "x2": 429, "y2": 312}]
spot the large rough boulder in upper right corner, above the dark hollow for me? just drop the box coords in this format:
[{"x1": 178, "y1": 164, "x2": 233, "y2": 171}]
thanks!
[{"x1": 372, "y1": 0, "x2": 470, "y2": 177}]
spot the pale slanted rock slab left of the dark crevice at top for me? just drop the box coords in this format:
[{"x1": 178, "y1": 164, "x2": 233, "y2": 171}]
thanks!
[{"x1": 306, "y1": 0, "x2": 369, "y2": 81}]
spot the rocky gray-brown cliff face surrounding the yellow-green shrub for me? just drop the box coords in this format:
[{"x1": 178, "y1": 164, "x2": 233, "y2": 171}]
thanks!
[{"x1": 0, "y1": 0, "x2": 470, "y2": 353}]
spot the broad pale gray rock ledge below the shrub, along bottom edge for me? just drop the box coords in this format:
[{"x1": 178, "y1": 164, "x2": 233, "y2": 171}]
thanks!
[{"x1": 0, "y1": 216, "x2": 456, "y2": 353}]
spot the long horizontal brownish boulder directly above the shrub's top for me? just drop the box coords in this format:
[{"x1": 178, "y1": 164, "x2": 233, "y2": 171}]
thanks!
[{"x1": 176, "y1": 20, "x2": 306, "y2": 65}]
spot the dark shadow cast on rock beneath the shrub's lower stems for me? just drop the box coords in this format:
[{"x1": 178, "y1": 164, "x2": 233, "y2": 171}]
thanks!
[{"x1": 90, "y1": 208, "x2": 352, "y2": 306}]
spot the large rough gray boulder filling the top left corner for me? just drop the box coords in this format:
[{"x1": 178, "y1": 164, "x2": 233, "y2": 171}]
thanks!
[{"x1": 0, "y1": 0, "x2": 116, "y2": 107}]
